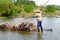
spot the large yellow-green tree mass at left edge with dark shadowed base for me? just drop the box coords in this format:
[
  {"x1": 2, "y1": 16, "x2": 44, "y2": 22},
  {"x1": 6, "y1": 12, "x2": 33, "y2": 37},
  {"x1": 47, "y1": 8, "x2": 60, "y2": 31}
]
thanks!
[{"x1": 0, "y1": 0, "x2": 19, "y2": 16}]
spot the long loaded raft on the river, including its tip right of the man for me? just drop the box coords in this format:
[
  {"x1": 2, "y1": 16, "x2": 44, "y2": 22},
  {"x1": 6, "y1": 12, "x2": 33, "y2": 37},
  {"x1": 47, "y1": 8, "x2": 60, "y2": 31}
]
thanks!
[{"x1": 0, "y1": 22, "x2": 52, "y2": 33}]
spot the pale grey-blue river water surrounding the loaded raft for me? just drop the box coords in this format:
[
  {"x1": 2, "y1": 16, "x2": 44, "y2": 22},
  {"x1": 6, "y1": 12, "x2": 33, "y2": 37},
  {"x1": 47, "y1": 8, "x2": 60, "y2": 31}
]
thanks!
[{"x1": 0, "y1": 17, "x2": 60, "y2": 40}]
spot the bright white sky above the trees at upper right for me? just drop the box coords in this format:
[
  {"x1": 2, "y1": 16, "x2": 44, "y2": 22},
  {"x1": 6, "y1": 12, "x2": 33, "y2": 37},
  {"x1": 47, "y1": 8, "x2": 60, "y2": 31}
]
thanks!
[{"x1": 33, "y1": 0, "x2": 60, "y2": 6}]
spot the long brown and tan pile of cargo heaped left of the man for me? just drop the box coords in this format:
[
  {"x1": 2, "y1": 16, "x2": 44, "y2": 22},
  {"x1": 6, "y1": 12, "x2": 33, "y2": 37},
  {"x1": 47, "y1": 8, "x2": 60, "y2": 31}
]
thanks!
[{"x1": 0, "y1": 22, "x2": 36, "y2": 32}]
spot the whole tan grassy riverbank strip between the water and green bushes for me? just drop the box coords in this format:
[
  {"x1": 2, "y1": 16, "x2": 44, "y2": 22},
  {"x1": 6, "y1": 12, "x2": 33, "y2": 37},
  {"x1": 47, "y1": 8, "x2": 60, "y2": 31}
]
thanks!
[{"x1": 0, "y1": 11, "x2": 60, "y2": 19}]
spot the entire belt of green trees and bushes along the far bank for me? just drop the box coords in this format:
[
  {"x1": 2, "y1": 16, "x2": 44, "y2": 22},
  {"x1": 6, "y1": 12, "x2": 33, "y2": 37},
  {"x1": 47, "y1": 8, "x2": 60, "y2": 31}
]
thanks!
[{"x1": 0, "y1": 0, "x2": 60, "y2": 17}]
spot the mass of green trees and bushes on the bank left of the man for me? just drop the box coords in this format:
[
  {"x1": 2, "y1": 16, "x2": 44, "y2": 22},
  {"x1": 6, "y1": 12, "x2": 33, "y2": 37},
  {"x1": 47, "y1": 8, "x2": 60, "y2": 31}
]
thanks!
[{"x1": 0, "y1": 0, "x2": 35, "y2": 17}]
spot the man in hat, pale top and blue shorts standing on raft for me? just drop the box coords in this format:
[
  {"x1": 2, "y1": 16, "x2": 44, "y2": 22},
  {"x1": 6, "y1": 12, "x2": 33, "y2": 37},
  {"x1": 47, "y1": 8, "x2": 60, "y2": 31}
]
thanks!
[{"x1": 34, "y1": 10, "x2": 43, "y2": 32}]
